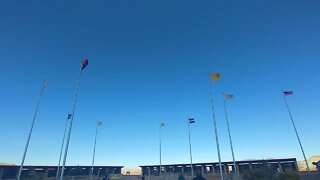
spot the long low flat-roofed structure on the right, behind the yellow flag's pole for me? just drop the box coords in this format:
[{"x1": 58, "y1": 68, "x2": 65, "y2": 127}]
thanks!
[{"x1": 140, "y1": 158, "x2": 298, "y2": 176}]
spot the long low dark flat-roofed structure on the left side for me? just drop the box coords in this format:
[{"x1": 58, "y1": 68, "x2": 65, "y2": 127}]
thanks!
[{"x1": 0, "y1": 164, "x2": 123, "y2": 179}]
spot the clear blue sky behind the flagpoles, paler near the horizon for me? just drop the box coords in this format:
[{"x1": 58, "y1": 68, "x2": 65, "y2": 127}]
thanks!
[{"x1": 0, "y1": 0, "x2": 320, "y2": 168}]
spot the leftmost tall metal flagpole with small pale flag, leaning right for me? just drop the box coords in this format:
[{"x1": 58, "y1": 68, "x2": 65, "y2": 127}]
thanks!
[{"x1": 17, "y1": 80, "x2": 48, "y2": 180}]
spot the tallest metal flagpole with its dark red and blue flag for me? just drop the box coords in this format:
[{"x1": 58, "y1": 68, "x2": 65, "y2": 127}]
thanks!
[{"x1": 60, "y1": 59, "x2": 88, "y2": 180}]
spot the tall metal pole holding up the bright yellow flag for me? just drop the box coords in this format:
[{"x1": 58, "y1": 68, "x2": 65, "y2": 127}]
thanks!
[{"x1": 209, "y1": 74, "x2": 223, "y2": 180}]
